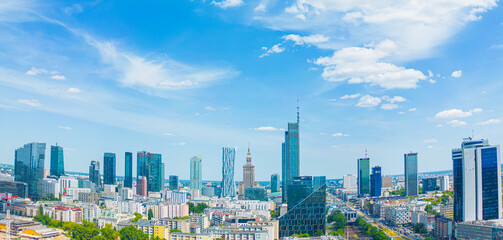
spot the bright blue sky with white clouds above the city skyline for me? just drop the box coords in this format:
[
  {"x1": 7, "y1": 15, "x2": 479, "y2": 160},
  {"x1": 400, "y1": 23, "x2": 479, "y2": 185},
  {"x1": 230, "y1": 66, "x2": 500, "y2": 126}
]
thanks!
[{"x1": 0, "y1": 0, "x2": 503, "y2": 180}]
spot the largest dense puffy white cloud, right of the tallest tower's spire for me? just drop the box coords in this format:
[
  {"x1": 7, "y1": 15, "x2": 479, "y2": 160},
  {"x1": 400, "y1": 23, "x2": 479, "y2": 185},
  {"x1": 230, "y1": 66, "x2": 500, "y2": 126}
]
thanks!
[{"x1": 314, "y1": 40, "x2": 426, "y2": 89}]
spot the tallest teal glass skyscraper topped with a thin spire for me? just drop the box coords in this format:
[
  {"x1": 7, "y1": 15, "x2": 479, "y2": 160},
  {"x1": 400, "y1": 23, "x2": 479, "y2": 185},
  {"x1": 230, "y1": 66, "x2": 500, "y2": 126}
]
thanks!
[{"x1": 281, "y1": 105, "x2": 300, "y2": 202}]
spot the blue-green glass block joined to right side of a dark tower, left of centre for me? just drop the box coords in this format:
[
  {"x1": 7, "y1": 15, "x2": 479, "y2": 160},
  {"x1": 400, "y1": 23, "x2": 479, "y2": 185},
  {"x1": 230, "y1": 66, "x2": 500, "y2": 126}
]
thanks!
[{"x1": 145, "y1": 153, "x2": 164, "y2": 192}]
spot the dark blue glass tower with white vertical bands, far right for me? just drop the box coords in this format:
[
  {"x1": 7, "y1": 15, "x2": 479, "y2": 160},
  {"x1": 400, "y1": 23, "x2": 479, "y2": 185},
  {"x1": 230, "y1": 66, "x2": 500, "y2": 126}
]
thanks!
[{"x1": 452, "y1": 138, "x2": 502, "y2": 222}]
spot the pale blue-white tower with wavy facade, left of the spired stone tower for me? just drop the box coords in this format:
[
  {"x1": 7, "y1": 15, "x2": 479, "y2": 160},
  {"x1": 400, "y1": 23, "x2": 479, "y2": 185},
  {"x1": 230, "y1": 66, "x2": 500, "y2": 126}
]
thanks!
[{"x1": 222, "y1": 147, "x2": 236, "y2": 197}]
